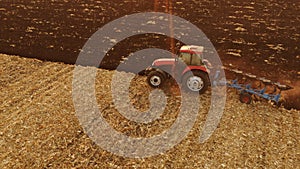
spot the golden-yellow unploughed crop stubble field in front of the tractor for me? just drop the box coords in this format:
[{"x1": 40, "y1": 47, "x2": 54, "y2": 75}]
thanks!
[{"x1": 0, "y1": 55, "x2": 300, "y2": 168}]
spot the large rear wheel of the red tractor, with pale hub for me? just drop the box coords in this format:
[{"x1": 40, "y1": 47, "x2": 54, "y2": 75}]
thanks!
[{"x1": 182, "y1": 71, "x2": 209, "y2": 94}]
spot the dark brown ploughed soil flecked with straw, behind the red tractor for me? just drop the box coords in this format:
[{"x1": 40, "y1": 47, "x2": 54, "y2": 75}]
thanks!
[{"x1": 0, "y1": 0, "x2": 300, "y2": 83}]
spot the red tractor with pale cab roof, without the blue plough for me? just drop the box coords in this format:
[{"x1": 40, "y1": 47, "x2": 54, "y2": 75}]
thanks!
[{"x1": 145, "y1": 45, "x2": 211, "y2": 94}]
